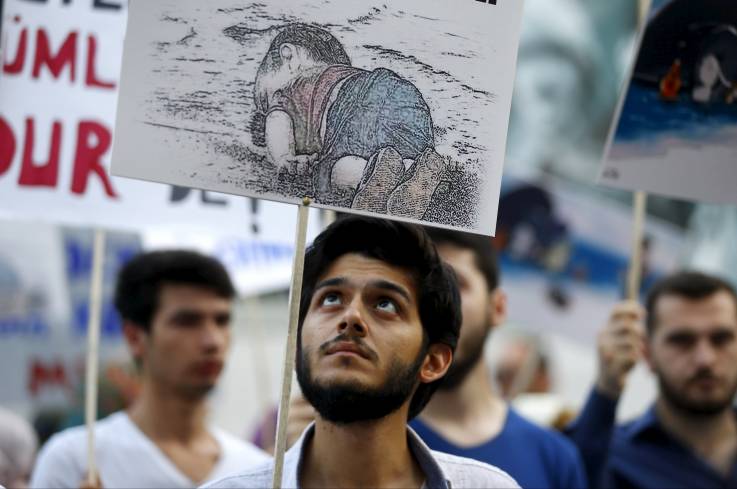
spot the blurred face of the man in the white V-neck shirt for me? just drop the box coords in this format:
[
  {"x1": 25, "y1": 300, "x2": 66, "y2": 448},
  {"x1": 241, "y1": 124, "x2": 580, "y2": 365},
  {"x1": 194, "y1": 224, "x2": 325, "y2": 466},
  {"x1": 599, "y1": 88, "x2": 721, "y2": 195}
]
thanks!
[{"x1": 126, "y1": 284, "x2": 231, "y2": 398}]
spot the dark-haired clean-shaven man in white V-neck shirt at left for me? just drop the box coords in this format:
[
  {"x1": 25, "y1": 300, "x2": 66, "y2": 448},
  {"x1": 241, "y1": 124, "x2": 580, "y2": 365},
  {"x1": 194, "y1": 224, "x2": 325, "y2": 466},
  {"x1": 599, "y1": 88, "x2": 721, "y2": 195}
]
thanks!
[{"x1": 31, "y1": 251, "x2": 269, "y2": 488}]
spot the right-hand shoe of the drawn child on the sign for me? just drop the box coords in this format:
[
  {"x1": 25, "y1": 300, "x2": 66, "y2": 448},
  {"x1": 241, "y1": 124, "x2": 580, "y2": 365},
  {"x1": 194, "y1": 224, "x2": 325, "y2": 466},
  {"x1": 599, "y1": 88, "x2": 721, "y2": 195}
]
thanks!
[{"x1": 387, "y1": 148, "x2": 447, "y2": 219}]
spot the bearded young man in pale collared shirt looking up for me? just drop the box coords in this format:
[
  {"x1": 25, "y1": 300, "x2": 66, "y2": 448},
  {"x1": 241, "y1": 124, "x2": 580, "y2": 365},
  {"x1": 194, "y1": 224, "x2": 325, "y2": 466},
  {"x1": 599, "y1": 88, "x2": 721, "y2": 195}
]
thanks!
[{"x1": 210, "y1": 217, "x2": 518, "y2": 488}]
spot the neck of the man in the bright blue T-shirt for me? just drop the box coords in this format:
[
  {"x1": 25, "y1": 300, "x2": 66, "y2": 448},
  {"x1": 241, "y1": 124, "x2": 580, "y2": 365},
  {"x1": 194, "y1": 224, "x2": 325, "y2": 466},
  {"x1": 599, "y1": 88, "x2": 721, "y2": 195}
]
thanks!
[{"x1": 421, "y1": 358, "x2": 507, "y2": 447}]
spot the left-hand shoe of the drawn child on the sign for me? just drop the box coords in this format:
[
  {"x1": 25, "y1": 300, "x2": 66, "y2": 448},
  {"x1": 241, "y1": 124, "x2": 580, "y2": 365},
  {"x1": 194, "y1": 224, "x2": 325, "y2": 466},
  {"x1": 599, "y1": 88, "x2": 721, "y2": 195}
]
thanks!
[{"x1": 351, "y1": 148, "x2": 404, "y2": 214}]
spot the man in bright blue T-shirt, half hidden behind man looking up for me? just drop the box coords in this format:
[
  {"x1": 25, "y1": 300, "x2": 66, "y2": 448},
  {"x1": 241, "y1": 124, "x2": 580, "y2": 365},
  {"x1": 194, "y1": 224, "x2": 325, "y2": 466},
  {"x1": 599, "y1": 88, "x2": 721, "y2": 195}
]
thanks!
[{"x1": 411, "y1": 229, "x2": 587, "y2": 488}]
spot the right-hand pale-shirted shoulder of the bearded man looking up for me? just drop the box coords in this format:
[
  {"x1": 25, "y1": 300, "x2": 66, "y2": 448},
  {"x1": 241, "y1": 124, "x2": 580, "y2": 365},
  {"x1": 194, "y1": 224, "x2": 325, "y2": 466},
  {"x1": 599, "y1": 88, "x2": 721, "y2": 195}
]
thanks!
[{"x1": 432, "y1": 450, "x2": 519, "y2": 488}]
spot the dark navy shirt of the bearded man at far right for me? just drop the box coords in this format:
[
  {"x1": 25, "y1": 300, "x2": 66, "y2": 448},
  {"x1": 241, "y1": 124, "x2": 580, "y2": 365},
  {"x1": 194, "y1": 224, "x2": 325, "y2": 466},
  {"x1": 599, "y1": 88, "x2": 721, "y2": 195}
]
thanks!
[{"x1": 568, "y1": 390, "x2": 737, "y2": 489}]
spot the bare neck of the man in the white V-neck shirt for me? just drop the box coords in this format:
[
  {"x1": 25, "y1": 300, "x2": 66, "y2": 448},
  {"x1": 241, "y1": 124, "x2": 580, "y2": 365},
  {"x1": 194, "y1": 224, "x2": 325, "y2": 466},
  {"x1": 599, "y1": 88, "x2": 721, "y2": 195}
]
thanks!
[{"x1": 128, "y1": 381, "x2": 209, "y2": 445}]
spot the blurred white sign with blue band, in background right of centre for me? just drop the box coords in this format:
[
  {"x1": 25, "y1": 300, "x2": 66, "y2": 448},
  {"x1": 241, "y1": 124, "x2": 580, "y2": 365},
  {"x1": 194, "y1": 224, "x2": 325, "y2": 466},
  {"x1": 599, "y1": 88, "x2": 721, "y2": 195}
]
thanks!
[{"x1": 494, "y1": 177, "x2": 686, "y2": 344}]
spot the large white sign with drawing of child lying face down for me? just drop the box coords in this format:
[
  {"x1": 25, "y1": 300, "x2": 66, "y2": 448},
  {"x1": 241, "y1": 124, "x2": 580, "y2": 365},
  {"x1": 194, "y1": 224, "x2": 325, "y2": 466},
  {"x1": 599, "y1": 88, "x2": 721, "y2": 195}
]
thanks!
[{"x1": 112, "y1": 0, "x2": 522, "y2": 234}]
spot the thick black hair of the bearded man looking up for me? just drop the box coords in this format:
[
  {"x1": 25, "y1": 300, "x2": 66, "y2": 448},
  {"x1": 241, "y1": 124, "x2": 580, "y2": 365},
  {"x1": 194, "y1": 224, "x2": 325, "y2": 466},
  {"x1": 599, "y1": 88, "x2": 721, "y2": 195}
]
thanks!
[{"x1": 298, "y1": 216, "x2": 461, "y2": 419}]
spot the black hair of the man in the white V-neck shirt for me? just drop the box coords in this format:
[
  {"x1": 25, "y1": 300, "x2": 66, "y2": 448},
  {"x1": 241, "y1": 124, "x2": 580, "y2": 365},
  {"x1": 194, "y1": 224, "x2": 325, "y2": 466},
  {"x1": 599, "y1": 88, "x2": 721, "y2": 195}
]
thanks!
[{"x1": 115, "y1": 250, "x2": 235, "y2": 332}]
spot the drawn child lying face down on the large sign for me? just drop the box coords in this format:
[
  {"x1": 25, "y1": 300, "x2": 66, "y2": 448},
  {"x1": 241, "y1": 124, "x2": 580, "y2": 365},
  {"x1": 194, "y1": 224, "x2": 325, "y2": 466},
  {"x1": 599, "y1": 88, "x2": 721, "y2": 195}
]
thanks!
[{"x1": 254, "y1": 24, "x2": 447, "y2": 219}]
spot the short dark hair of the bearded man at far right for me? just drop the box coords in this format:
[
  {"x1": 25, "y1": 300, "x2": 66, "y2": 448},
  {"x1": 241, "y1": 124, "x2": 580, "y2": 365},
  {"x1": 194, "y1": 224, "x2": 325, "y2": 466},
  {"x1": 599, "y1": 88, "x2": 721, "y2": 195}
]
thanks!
[{"x1": 645, "y1": 270, "x2": 737, "y2": 335}]
